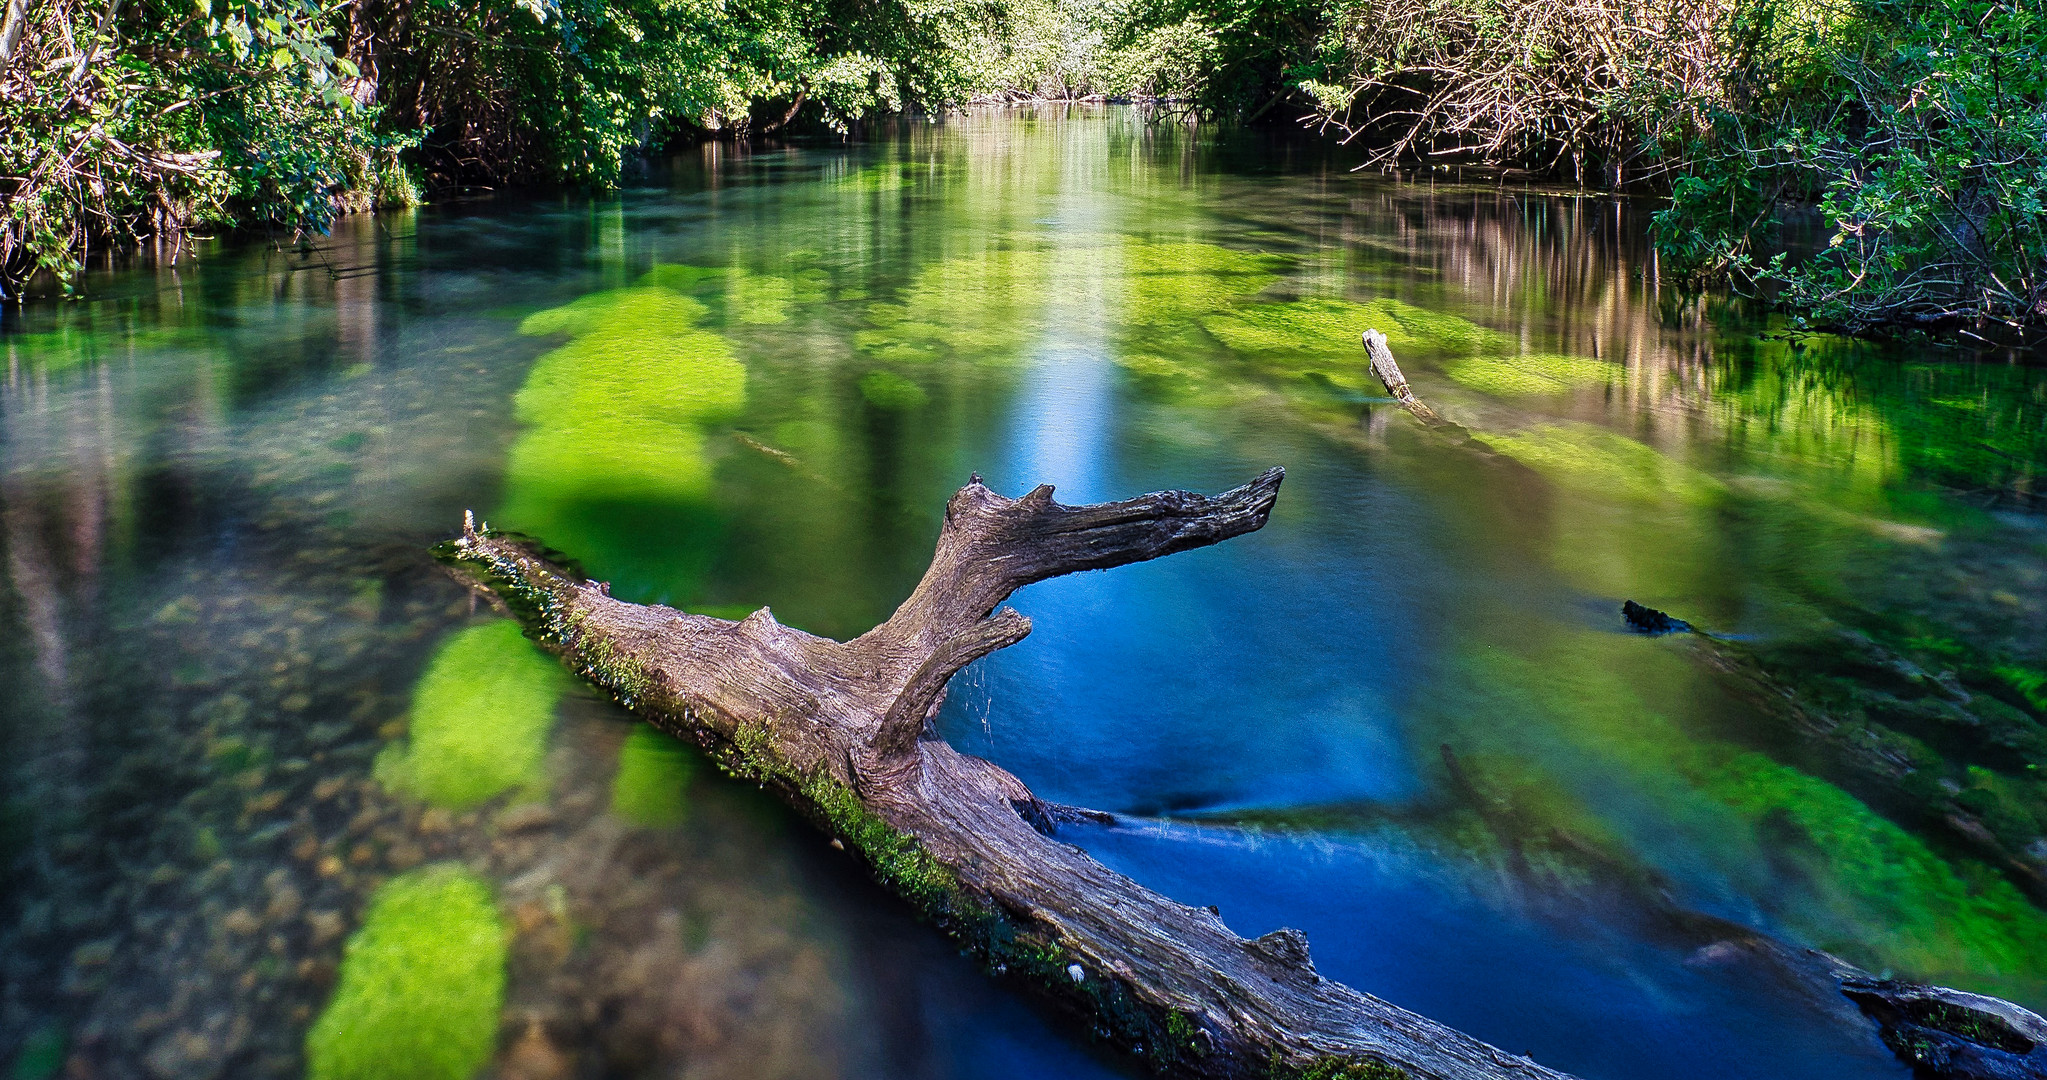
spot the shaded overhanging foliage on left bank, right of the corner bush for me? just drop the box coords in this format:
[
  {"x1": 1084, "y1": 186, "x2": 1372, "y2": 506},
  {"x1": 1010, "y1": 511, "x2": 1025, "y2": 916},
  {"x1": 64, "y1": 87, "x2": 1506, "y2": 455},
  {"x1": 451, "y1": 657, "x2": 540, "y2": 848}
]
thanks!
[{"x1": 371, "y1": 0, "x2": 991, "y2": 184}]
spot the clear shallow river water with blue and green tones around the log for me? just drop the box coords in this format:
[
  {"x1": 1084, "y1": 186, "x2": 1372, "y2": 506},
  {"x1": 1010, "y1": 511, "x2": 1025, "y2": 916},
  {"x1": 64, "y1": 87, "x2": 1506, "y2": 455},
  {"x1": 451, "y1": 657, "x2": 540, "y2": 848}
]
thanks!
[{"x1": 0, "y1": 113, "x2": 2047, "y2": 1078}]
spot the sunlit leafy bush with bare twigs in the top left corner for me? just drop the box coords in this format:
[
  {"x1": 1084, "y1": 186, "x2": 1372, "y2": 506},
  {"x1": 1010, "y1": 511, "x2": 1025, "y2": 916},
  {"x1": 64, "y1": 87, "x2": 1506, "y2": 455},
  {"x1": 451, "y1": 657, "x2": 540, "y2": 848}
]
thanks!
[{"x1": 0, "y1": 0, "x2": 416, "y2": 290}]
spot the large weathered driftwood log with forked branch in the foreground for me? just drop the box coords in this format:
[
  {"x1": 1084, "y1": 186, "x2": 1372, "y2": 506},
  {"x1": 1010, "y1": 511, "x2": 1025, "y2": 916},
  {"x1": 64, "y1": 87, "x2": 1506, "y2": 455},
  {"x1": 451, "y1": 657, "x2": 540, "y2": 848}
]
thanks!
[{"x1": 440, "y1": 468, "x2": 1560, "y2": 1080}]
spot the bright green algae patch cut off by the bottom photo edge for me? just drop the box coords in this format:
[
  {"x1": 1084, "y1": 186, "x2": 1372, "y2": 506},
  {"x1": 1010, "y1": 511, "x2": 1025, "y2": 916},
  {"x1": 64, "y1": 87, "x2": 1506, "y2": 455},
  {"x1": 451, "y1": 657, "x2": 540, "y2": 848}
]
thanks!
[{"x1": 305, "y1": 863, "x2": 508, "y2": 1080}]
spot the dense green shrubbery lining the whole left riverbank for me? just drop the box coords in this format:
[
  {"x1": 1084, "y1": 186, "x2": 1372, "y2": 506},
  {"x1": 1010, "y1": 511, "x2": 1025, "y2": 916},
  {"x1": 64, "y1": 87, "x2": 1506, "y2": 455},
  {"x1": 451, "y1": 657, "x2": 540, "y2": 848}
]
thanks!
[{"x1": 0, "y1": 0, "x2": 995, "y2": 286}]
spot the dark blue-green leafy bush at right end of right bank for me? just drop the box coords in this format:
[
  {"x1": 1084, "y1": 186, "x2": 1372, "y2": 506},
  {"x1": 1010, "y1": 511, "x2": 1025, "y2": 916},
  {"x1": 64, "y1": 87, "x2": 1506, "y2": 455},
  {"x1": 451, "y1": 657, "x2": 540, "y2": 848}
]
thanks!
[{"x1": 1656, "y1": 0, "x2": 2047, "y2": 327}]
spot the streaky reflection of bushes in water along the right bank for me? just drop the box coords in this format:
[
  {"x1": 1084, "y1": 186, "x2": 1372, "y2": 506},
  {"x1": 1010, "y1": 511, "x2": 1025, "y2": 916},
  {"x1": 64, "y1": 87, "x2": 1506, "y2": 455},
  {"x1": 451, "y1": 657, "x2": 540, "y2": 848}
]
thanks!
[{"x1": 1343, "y1": 184, "x2": 2047, "y2": 503}]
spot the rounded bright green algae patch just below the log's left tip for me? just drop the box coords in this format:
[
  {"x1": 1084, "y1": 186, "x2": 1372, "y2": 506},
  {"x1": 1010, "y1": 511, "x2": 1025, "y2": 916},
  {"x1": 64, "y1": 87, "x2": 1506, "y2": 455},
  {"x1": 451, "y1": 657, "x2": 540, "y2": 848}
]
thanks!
[{"x1": 377, "y1": 620, "x2": 565, "y2": 808}]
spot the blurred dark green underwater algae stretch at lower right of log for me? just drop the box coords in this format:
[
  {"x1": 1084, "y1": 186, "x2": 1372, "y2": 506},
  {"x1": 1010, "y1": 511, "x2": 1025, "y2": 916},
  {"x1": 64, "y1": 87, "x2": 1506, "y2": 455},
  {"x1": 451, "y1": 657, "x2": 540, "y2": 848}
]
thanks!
[{"x1": 1465, "y1": 628, "x2": 2047, "y2": 998}]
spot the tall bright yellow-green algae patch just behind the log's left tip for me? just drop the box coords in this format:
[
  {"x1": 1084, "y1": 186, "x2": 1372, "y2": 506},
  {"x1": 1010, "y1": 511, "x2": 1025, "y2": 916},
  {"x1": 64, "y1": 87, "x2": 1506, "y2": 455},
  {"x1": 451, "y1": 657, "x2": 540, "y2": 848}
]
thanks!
[{"x1": 491, "y1": 268, "x2": 749, "y2": 601}]
